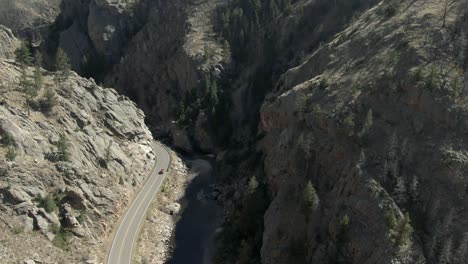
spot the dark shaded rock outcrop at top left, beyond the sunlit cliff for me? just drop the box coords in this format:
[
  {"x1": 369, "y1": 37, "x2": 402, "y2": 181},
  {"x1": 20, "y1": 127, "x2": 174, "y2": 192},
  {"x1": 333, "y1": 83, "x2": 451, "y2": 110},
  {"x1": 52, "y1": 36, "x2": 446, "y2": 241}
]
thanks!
[{"x1": 52, "y1": 0, "x2": 136, "y2": 70}]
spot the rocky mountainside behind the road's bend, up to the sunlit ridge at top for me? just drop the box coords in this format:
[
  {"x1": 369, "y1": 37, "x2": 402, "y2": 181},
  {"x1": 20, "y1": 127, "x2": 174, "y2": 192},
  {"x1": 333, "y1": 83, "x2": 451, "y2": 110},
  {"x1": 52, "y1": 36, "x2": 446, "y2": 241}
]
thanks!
[{"x1": 49, "y1": 0, "x2": 230, "y2": 151}]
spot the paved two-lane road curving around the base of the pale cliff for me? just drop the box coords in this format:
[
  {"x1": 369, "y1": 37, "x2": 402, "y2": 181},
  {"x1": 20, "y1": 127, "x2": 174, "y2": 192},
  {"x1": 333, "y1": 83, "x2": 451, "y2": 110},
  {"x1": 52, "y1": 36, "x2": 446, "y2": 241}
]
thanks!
[{"x1": 107, "y1": 143, "x2": 170, "y2": 264}]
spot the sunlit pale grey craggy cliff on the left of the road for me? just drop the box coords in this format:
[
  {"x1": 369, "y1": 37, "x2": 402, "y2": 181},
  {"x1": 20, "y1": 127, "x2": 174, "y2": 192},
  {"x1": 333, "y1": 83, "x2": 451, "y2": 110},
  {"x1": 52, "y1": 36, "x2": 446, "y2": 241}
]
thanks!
[{"x1": 0, "y1": 55, "x2": 155, "y2": 263}]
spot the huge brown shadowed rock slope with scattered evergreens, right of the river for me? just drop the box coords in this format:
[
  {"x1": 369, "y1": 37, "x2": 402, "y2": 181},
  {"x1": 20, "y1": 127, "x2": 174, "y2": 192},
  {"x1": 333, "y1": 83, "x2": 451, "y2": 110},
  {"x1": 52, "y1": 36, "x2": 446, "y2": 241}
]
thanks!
[{"x1": 261, "y1": 1, "x2": 468, "y2": 263}]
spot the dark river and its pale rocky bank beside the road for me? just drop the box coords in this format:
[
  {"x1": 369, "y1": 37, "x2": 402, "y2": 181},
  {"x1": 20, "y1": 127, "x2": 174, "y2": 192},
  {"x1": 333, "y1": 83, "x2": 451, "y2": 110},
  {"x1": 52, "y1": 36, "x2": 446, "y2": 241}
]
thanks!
[{"x1": 134, "y1": 151, "x2": 222, "y2": 264}]
